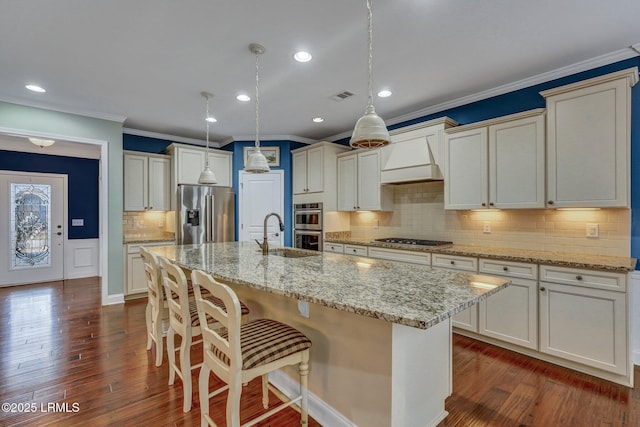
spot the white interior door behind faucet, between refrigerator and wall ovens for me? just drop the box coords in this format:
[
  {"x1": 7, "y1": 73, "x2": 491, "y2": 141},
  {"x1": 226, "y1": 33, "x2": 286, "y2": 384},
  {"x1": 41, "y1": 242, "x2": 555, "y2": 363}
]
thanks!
[{"x1": 238, "y1": 170, "x2": 284, "y2": 246}]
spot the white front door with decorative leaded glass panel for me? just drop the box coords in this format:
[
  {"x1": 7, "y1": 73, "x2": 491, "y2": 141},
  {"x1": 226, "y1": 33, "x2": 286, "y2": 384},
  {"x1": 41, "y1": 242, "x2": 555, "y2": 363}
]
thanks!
[{"x1": 0, "y1": 171, "x2": 67, "y2": 286}]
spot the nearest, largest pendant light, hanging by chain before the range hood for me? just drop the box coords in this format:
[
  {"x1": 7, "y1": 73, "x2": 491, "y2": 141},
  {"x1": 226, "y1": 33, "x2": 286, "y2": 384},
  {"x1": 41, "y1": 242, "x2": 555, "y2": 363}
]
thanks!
[{"x1": 349, "y1": 0, "x2": 391, "y2": 148}]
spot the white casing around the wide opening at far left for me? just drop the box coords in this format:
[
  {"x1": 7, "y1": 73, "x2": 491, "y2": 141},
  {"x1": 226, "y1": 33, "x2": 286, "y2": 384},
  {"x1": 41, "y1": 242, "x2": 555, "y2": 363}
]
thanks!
[{"x1": 0, "y1": 126, "x2": 110, "y2": 305}]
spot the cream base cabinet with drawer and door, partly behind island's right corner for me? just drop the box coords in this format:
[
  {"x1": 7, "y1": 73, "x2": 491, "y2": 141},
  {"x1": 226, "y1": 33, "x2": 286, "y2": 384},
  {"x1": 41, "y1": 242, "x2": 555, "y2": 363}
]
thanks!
[{"x1": 478, "y1": 258, "x2": 538, "y2": 350}]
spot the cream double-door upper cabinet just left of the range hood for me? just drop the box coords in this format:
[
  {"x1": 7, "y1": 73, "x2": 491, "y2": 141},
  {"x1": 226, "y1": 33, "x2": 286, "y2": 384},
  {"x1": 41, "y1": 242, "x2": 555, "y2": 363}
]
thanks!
[{"x1": 338, "y1": 150, "x2": 393, "y2": 211}]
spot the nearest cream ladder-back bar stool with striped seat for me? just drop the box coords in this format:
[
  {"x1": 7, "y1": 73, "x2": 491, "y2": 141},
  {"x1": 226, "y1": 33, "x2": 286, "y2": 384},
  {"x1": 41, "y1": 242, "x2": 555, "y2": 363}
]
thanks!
[{"x1": 191, "y1": 270, "x2": 311, "y2": 427}]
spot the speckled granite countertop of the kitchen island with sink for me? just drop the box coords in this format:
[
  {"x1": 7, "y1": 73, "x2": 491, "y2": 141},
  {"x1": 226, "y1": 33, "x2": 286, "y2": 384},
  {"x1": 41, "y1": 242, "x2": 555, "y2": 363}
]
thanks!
[{"x1": 150, "y1": 242, "x2": 510, "y2": 329}]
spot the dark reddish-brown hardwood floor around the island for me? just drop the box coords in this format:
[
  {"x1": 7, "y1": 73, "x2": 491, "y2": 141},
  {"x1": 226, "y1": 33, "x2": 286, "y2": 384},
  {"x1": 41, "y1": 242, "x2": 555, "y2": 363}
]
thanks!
[{"x1": 0, "y1": 279, "x2": 640, "y2": 427}]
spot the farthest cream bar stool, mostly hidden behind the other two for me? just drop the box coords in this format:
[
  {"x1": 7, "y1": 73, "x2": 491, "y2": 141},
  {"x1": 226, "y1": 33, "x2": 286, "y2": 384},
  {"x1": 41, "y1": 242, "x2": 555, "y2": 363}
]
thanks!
[{"x1": 140, "y1": 246, "x2": 169, "y2": 366}]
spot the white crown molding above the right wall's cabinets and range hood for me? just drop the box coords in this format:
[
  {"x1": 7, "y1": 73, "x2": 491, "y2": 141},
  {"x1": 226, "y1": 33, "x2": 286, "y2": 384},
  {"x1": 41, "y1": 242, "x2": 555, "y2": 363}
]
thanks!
[{"x1": 326, "y1": 43, "x2": 640, "y2": 141}]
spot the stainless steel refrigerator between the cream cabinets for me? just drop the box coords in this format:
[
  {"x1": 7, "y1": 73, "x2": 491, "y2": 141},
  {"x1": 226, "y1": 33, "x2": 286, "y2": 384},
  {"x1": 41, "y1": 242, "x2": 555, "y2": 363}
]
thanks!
[{"x1": 176, "y1": 184, "x2": 236, "y2": 245}]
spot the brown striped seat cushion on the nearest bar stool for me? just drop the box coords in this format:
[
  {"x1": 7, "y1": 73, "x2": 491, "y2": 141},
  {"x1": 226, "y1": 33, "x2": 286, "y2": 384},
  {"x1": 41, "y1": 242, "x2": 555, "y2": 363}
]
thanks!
[{"x1": 211, "y1": 319, "x2": 311, "y2": 369}]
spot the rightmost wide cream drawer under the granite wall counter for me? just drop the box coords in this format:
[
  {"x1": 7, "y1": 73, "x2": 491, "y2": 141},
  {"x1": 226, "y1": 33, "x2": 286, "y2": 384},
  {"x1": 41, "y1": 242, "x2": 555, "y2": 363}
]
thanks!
[{"x1": 540, "y1": 265, "x2": 627, "y2": 292}]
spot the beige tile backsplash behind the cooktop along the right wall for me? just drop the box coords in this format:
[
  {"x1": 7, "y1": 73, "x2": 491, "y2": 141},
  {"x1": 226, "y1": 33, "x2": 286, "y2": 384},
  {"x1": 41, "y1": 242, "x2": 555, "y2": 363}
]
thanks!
[{"x1": 350, "y1": 182, "x2": 631, "y2": 257}]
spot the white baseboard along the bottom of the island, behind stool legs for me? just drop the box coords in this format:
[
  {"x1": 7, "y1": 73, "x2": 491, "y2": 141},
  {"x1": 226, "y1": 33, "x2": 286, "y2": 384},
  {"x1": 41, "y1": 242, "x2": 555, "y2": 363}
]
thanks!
[{"x1": 269, "y1": 370, "x2": 356, "y2": 427}]
